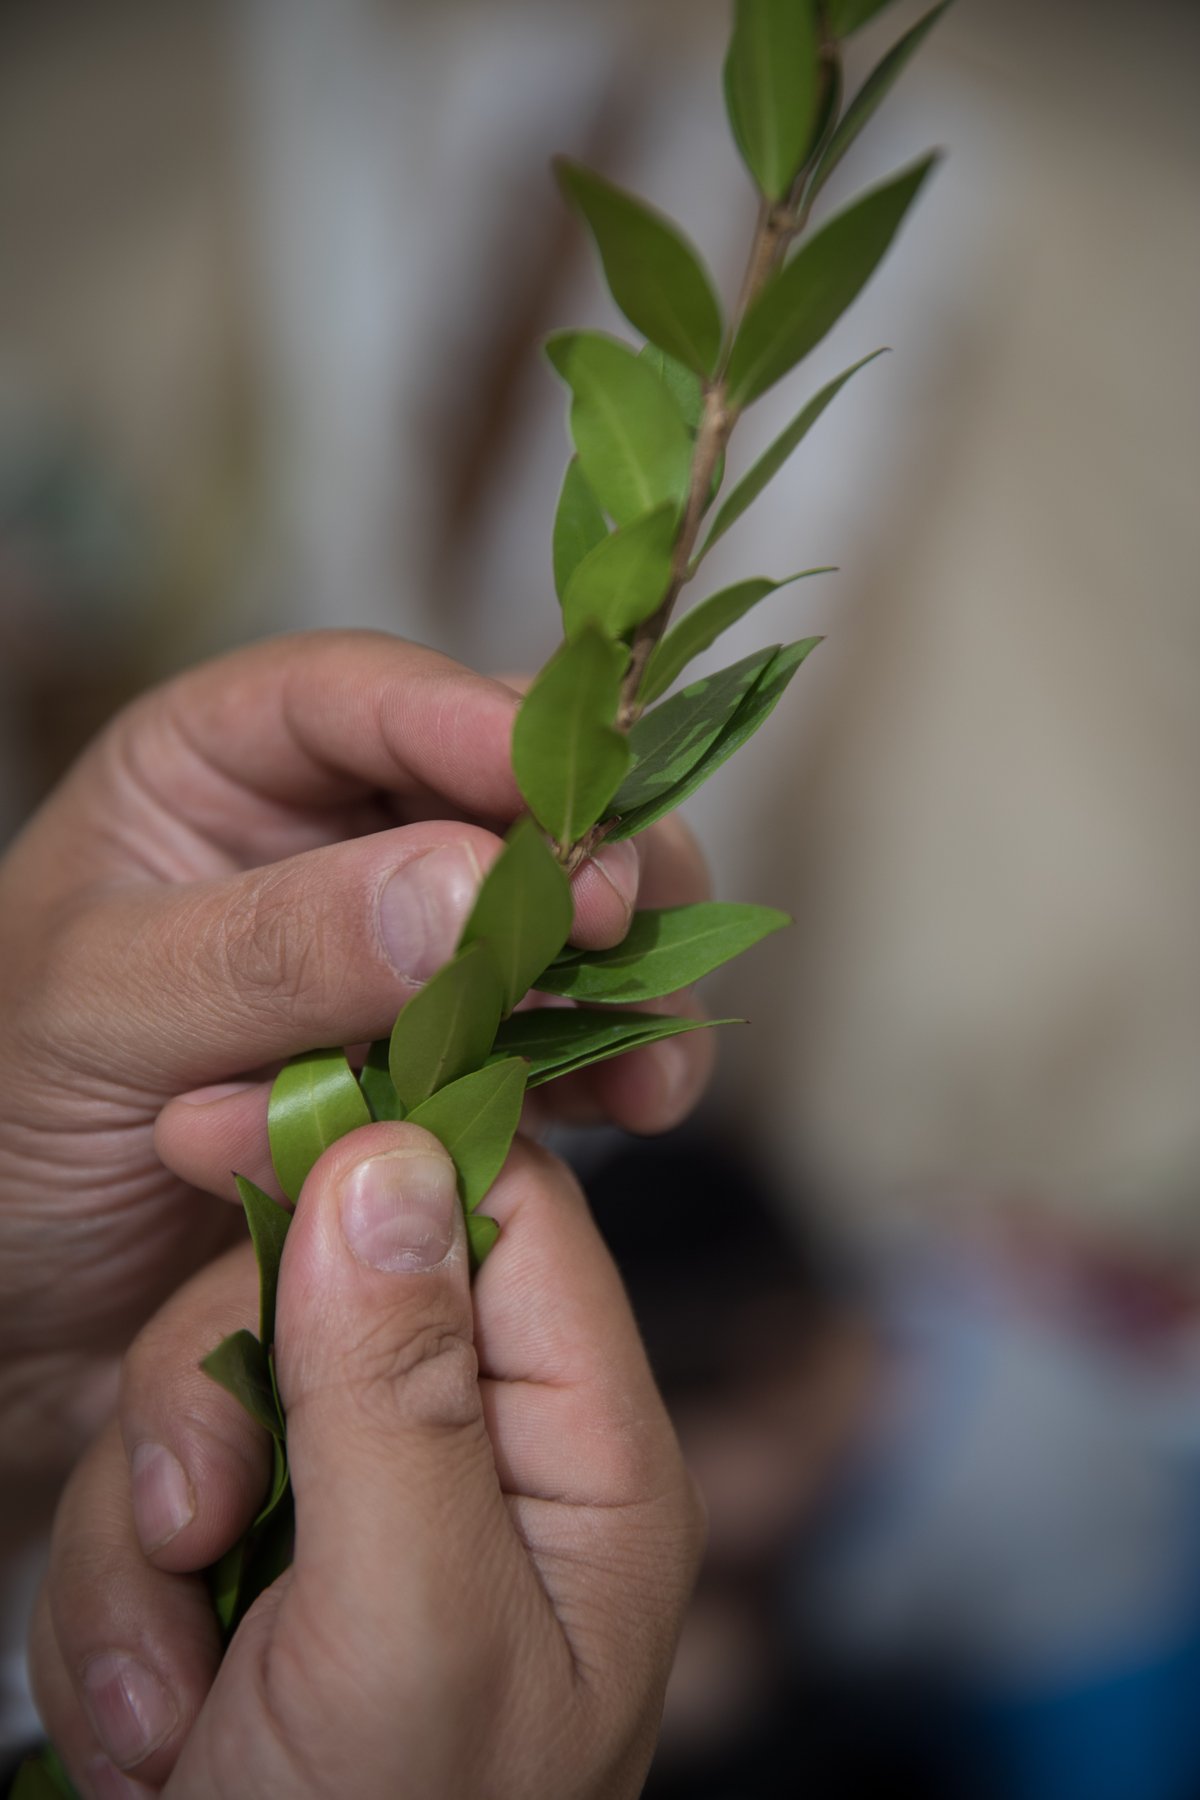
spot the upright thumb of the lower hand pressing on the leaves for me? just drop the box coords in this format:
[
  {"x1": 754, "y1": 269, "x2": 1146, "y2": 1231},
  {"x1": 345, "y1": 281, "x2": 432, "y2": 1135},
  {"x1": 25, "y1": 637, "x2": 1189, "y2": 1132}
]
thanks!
[{"x1": 275, "y1": 1125, "x2": 515, "y2": 1706}]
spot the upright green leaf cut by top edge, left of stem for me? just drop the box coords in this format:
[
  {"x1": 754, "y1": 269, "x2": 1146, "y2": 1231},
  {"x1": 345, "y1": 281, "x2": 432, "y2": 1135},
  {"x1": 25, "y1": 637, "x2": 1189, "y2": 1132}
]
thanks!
[{"x1": 725, "y1": 0, "x2": 820, "y2": 200}]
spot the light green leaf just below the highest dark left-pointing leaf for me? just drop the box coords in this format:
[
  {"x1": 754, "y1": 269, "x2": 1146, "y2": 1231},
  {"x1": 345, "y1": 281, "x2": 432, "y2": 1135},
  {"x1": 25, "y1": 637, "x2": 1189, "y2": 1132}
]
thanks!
[{"x1": 545, "y1": 331, "x2": 691, "y2": 526}]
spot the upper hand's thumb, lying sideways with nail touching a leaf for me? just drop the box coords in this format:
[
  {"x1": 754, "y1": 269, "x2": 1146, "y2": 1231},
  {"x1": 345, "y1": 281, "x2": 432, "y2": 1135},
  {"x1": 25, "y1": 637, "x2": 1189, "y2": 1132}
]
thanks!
[{"x1": 52, "y1": 824, "x2": 651, "y2": 1098}]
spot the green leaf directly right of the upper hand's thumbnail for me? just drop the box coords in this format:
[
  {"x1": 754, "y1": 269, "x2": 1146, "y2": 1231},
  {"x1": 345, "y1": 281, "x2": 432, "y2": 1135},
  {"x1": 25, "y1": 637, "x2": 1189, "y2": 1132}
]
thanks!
[{"x1": 459, "y1": 819, "x2": 574, "y2": 1013}]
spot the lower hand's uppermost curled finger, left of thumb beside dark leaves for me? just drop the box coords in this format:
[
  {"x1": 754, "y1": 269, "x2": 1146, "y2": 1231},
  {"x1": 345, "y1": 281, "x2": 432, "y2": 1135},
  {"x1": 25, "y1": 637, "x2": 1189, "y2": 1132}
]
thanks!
[{"x1": 119, "y1": 1244, "x2": 270, "y2": 1573}]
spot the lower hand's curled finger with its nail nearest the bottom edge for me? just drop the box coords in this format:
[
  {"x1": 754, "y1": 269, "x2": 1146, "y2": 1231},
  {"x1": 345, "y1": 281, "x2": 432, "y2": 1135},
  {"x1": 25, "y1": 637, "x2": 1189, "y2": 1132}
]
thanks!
[{"x1": 34, "y1": 1424, "x2": 219, "y2": 1796}]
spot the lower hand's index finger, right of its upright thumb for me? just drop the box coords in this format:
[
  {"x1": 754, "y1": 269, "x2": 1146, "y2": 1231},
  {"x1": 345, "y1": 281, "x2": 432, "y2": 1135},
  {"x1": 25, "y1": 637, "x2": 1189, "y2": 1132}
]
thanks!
[{"x1": 475, "y1": 1143, "x2": 703, "y2": 1694}]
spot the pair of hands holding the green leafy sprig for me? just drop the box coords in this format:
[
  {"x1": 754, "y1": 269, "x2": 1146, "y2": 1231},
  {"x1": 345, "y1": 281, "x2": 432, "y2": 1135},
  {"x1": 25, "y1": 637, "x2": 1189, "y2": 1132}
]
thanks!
[{"x1": 0, "y1": 634, "x2": 711, "y2": 1800}]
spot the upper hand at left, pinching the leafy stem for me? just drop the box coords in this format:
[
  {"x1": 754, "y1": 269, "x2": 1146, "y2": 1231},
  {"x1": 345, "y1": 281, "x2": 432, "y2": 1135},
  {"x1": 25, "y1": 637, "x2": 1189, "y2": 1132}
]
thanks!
[{"x1": 0, "y1": 632, "x2": 711, "y2": 1504}]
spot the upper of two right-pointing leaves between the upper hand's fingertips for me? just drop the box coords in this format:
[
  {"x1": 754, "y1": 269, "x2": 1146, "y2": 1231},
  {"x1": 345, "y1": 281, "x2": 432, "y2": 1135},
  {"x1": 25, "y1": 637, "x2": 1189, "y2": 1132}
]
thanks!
[{"x1": 538, "y1": 900, "x2": 792, "y2": 1006}]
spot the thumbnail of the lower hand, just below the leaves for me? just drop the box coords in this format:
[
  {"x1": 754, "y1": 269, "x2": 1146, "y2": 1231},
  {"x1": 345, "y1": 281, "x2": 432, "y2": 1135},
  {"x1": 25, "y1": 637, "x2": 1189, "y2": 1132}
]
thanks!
[{"x1": 342, "y1": 1150, "x2": 459, "y2": 1274}]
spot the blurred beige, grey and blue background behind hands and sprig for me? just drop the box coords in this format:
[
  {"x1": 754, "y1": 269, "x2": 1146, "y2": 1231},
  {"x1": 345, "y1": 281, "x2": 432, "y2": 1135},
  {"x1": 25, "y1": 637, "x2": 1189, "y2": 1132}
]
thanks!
[{"x1": 0, "y1": 0, "x2": 1200, "y2": 1800}]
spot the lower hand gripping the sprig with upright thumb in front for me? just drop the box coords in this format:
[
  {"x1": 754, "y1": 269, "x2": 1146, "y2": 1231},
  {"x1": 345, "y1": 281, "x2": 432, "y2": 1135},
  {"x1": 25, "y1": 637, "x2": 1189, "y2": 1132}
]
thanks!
[{"x1": 31, "y1": 1125, "x2": 703, "y2": 1800}]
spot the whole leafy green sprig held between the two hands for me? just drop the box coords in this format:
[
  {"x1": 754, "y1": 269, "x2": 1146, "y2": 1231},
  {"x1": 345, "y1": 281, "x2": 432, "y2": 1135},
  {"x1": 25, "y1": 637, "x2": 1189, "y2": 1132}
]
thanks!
[{"x1": 4, "y1": 10, "x2": 948, "y2": 1756}]
